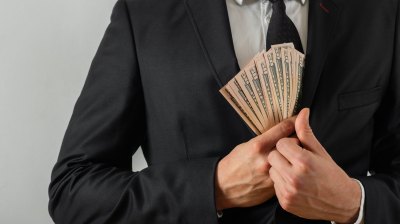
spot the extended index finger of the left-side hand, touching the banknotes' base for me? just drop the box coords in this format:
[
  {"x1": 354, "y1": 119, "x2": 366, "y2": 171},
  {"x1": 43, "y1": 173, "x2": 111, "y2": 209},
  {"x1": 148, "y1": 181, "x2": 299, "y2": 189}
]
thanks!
[{"x1": 254, "y1": 118, "x2": 295, "y2": 148}]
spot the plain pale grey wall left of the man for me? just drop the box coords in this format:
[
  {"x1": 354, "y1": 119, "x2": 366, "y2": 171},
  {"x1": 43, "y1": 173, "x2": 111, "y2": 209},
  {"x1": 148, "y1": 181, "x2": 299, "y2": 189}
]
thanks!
[{"x1": 0, "y1": 0, "x2": 145, "y2": 224}]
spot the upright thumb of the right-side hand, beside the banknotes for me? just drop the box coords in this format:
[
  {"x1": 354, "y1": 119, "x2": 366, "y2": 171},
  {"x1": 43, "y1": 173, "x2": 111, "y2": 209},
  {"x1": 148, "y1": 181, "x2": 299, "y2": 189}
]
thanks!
[{"x1": 295, "y1": 108, "x2": 326, "y2": 154}]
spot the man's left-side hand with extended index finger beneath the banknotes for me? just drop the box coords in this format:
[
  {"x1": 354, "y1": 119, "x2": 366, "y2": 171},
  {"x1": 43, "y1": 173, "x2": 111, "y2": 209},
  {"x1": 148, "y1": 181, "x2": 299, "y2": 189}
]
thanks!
[{"x1": 215, "y1": 118, "x2": 295, "y2": 210}]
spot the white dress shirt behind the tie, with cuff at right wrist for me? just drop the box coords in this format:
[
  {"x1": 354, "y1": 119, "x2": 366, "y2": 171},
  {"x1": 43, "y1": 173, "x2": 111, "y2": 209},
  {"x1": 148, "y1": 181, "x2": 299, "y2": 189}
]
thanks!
[{"x1": 226, "y1": 0, "x2": 365, "y2": 224}]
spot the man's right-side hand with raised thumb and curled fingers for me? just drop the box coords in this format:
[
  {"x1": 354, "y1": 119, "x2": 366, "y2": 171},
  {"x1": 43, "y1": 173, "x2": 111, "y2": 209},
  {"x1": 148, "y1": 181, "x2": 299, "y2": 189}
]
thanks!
[{"x1": 268, "y1": 109, "x2": 361, "y2": 223}]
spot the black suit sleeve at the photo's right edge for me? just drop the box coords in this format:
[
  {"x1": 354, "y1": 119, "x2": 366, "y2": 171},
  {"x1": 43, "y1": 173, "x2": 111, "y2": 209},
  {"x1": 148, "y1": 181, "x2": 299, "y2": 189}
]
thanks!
[{"x1": 358, "y1": 1, "x2": 400, "y2": 224}]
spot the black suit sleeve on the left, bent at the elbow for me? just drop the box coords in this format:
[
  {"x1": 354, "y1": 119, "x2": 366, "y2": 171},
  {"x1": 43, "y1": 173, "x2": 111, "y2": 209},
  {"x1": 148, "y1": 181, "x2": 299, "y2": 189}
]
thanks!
[{"x1": 49, "y1": 0, "x2": 219, "y2": 224}]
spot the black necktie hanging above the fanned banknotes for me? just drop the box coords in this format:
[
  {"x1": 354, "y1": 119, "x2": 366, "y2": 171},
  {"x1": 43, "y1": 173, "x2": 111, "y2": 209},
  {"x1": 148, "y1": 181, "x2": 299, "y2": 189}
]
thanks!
[{"x1": 267, "y1": 0, "x2": 304, "y2": 53}]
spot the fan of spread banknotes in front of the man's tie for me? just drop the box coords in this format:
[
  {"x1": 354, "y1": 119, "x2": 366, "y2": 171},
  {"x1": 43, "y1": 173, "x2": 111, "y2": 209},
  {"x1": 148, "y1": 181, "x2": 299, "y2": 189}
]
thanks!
[{"x1": 220, "y1": 43, "x2": 305, "y2": 135}]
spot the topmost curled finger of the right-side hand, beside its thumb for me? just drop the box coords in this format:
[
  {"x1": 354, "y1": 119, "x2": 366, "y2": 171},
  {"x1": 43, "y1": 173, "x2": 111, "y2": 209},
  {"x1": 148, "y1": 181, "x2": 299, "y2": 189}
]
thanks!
[{"x1": 276, "y1": 138, "x2": 307, "y2": 164}]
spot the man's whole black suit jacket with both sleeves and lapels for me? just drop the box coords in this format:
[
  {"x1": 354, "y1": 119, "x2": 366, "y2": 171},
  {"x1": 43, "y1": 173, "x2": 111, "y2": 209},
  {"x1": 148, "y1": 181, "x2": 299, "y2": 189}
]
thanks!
[{"x1": 49, "y1": 0, "x2": 400, "y2": 224}]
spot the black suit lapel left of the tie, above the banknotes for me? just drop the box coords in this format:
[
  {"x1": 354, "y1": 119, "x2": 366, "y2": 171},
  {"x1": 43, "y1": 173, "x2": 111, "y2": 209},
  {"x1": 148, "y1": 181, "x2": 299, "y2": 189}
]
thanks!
[{"x1": 185, "y1": 0, "x2": 240, "y2": 88}]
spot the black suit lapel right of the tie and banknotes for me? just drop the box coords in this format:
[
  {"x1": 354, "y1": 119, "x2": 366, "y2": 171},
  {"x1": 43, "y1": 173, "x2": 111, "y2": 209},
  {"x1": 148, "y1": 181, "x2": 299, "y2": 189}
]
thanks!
[{"x1": 301, "y1": 0, "x2": 341, "y2": 107}]
